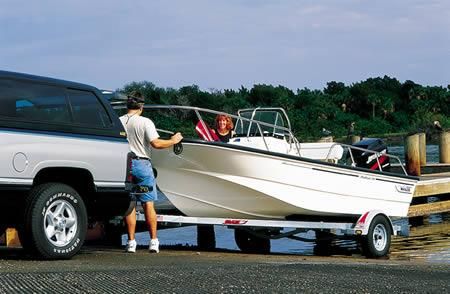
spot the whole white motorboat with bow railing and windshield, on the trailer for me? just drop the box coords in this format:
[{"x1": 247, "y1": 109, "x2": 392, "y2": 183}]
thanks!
[{"x1": 127, "y1": 105, "x2": 418, "y2": 219}]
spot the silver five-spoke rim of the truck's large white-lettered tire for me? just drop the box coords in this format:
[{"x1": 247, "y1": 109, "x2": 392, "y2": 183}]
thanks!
[{"x1": 44, "y1": 200, "x2": 78, "y2": 247}]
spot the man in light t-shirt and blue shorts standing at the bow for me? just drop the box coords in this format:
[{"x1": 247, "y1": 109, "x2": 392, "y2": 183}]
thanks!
[{"x1": 120, "y1": 91, "x2": 183, "y2": 253}]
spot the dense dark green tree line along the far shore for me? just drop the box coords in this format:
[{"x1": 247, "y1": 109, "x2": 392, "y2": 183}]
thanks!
[{"x1": 118, "y1": 76, "x2": 450, "y2": 141}]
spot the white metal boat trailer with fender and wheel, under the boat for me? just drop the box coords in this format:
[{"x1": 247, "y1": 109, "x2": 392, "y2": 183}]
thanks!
[{"x1": 122, "y1": 210, "x2": 409, "y2": 258}]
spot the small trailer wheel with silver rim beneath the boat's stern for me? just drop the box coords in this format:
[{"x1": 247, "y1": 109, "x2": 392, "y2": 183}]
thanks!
[{"x1": 361, "y1": 215, "x2": 392, "y2": 258}]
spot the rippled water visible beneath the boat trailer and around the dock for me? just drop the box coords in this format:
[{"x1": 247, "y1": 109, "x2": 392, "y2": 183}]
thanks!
[{"x1": 131, "y1": 145, "x2": 450, "y2": 264}]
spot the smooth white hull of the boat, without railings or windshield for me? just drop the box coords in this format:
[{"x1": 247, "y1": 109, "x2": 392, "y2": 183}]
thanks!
[{"x1": 152, "y1": 142, "x2": 416, "y2": 219}]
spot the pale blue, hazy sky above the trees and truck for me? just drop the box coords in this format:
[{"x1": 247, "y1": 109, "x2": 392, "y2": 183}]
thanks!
[{"x1": 0, "y1": 0, "x2": 450, "y2": 91}]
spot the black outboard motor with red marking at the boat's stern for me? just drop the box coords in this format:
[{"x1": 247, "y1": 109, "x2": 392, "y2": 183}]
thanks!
[{"x1": 352, "y1": 138, "x2": 390, "y2": 171}]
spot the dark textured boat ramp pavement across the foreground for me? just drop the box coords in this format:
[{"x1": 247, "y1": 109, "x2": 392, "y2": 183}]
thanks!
[{"x1": 0, "y1": 247, "x2": 450, "y2": 293}]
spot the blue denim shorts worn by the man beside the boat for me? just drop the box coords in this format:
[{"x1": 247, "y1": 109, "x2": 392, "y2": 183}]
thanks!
[{"x1": 131, "y1": 159, "x2": 158, "y2": 203}]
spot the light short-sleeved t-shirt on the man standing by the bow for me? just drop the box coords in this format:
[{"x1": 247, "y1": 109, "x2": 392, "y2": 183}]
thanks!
[{"x1": 120, "y1": 114, "x2": 159, "y2": 158}]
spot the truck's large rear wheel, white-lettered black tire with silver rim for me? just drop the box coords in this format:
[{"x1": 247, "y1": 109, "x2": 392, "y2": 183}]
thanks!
[{"x1": 21, "y1": 183, "x2": 87, "y2": 259}]
